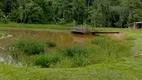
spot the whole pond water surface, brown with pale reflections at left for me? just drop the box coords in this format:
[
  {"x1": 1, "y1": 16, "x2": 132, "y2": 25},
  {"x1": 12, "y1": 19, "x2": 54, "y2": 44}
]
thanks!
[{"x1": 0, "y1": 29, "x2": 94, "y2": 65}]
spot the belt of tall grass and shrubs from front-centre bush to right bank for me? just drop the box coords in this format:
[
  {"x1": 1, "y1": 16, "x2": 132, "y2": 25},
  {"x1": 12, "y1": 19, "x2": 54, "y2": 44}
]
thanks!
[{"x1": 36, "y1": 36, "x2": 131, "y2": 68}]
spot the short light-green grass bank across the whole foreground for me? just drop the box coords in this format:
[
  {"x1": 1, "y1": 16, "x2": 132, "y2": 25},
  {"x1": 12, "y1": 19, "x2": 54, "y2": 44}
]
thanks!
[{"x1": 0, "y1": 58, "x2": 142, "y2": 80}]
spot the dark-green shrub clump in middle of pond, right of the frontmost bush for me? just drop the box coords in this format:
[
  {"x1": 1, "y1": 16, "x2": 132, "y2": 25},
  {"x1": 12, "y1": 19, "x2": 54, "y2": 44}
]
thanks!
[{"x1": 59, "y1": 45, "x2": 88, "y2": 67}]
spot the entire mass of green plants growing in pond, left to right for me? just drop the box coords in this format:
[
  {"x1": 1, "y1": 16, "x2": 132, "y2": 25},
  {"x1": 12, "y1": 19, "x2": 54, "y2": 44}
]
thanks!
[{"x1": 10, "y1": 36, "x2": 133, "y2": 68}]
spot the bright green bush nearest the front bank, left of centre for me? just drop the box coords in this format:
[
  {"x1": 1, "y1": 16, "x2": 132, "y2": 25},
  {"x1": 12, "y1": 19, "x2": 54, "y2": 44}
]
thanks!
[{"x1": 35, "y1": 53, "x2": 62, "y2": 68}]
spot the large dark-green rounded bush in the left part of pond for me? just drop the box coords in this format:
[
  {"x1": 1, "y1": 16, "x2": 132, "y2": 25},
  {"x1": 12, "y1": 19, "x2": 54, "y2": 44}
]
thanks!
[{"x1": 14, "y1": 39, "x2": 44, "y2": 54}]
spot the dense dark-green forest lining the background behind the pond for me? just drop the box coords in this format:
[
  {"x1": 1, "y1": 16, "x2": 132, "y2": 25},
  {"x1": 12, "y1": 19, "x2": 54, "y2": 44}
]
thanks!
[{"x1": 0, "y1": 0, "x2": 142, "y2": 27}]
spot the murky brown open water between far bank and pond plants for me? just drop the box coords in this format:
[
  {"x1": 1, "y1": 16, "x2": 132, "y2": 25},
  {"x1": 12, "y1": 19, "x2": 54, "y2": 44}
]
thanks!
[{"x1": 0, "y1": 29, "x2": 94, "y2": 45}]
